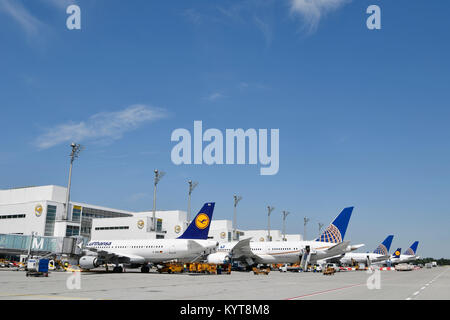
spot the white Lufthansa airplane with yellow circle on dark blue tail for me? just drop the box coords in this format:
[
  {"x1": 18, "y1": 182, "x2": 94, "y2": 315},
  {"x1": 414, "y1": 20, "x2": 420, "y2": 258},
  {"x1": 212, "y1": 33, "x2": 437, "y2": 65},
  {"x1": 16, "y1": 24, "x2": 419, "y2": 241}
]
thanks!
[{"x1": 79, "y1": 202, "x2": 219, "y2": 272}]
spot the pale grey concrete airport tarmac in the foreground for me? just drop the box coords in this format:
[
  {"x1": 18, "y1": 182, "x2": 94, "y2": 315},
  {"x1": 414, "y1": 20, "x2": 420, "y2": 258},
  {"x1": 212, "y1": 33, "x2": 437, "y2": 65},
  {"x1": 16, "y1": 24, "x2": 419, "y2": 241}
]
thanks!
[{"x1": 0, "y1": 267, "x2": 450, "y2": 300}]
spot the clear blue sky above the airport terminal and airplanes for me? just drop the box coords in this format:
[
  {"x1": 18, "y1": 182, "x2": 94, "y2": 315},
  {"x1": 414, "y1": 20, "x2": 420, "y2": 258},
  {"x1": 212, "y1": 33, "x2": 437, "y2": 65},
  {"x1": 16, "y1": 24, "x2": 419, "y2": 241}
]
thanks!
[{"x1": 0, "y1": 0, "x2": 450, "y2": 258}]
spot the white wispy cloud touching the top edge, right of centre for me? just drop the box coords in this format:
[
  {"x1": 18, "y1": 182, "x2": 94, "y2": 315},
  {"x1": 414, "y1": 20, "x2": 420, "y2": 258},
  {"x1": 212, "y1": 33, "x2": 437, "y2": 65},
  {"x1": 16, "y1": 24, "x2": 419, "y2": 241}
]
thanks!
[{"x1": 290, "y1": 0, "x2": 352, "y2": 33}]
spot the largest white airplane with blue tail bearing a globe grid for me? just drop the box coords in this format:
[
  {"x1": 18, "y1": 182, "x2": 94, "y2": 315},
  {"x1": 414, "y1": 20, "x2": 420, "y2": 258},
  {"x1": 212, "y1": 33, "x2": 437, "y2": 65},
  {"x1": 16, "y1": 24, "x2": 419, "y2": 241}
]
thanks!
[{"x1": 207, "y1": 207, "x2": 358, "y2": 266}]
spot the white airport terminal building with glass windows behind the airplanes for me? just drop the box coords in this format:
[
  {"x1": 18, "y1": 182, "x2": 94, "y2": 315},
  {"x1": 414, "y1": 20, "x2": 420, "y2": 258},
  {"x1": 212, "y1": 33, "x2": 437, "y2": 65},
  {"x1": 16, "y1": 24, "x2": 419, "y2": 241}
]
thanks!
[{"x1": 0, "y1": 185, "x2": 301, "y2": 254}]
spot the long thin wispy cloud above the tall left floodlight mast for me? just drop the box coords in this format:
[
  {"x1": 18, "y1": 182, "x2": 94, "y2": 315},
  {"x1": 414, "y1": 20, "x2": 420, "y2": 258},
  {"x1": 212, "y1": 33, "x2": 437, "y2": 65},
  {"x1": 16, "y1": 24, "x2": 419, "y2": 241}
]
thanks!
[{"x1": 36, "y1": 104, "x2": 167, "y2": 149}]
